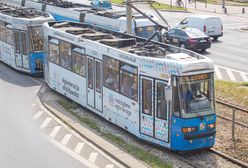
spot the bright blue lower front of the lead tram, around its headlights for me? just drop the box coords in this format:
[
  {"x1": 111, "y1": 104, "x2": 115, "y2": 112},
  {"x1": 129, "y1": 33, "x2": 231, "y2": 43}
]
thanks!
[{"x1": 171, "y1": 114, "x2": 216, "y2": 151}]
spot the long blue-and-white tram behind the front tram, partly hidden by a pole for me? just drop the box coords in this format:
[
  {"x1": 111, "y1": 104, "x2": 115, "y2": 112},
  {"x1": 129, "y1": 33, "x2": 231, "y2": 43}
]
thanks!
[{"x1": 3, "y1": 0, "x2": 160, "y2": 40}]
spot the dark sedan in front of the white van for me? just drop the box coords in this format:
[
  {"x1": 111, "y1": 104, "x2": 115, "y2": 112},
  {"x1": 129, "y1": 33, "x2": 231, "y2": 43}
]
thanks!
[{"x1": 163, "y1": 28, "x2": 211, "y2": 51}]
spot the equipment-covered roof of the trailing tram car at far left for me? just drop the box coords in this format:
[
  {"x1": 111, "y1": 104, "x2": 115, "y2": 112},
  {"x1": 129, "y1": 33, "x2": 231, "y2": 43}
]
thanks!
[{"x1": 0, "y1": 3, "x2": 50, "y2": 19}]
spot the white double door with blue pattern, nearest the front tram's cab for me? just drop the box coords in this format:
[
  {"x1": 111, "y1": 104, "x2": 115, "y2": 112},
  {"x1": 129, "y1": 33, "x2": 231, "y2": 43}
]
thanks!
[{"x1": 140, "y1": 77, "x2": 169, "y2": 142}]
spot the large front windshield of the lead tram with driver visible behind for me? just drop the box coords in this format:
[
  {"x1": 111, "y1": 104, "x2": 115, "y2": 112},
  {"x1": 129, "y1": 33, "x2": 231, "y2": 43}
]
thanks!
[{"x1": 174, "y1": 74, "x2": 214, "y2": 118}]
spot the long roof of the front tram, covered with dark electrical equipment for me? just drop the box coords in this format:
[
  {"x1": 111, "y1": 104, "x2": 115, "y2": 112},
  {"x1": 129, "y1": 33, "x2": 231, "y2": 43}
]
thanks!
[{"x1": 48, "y1": 22, "x2": 205, "y2": 60}]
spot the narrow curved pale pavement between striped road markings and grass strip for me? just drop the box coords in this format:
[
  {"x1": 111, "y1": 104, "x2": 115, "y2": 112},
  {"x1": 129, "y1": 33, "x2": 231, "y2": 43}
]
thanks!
[{"x1": 39, "y1": 84, "x2": 149, "y2": 168}]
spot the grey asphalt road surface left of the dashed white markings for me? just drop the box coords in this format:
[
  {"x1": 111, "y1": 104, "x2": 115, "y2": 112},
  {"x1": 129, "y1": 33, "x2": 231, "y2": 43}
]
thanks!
[{"x1": 0, "y1": 63, "x2": 86, "y2": 168}]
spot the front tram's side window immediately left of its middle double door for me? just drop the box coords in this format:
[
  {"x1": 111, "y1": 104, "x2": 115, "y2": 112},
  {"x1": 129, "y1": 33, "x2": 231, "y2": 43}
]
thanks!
[{"x1": 72, "y1": 51, "x2": 86, "y2": 76}]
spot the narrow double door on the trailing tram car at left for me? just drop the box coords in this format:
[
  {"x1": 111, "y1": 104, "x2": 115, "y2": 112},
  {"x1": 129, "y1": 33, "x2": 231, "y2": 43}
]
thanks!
[{"x1": 14, "y1": 31, "x2": 29, "y2": 69}]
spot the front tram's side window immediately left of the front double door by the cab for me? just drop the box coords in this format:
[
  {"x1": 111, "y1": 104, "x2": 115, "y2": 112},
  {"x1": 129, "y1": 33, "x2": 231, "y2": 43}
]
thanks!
[{"x1": 120, "y1": 62, "x2": 138, "y2": 101}]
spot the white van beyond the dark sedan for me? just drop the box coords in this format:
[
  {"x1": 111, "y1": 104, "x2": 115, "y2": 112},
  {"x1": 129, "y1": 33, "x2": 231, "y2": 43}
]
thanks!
[{"x1": 177, "y1": 15, "x2": 223, "y2": 40}]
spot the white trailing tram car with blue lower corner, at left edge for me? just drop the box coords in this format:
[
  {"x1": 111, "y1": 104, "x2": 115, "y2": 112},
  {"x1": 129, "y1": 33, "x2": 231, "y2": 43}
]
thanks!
[{"x1": 0, "y1": 3, "x2": 54, "y2": 75}]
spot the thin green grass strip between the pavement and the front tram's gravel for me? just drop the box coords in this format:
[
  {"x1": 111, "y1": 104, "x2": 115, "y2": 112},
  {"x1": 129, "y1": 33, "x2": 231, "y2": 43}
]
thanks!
[{"x1": 58, "y1": 99, "x2": 172, "y2": 168}]
